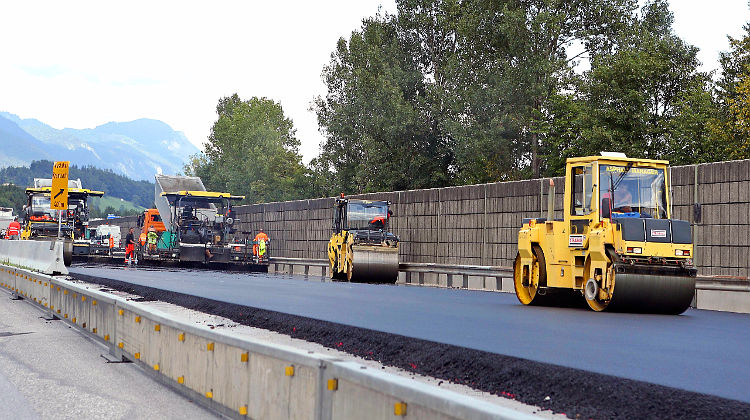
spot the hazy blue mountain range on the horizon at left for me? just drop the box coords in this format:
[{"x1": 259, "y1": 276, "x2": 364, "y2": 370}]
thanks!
[{"x1": 0, "y1": 112, "x2": 199, "y2": 182}]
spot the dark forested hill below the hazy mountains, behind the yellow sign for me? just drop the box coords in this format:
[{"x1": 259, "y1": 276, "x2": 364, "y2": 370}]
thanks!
[{"x1": 0, "y1": 160, "x2": 154, "y2": 210}]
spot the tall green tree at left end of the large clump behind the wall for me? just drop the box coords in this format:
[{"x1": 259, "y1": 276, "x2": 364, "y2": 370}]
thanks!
[{"x1": 315, "y1": 15, "x2": 452, "y2": 193}]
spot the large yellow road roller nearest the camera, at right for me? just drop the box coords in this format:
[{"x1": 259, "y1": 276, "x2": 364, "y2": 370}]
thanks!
[{"x1": 513, "y1": 153, "x2": 696, "y2": 314}]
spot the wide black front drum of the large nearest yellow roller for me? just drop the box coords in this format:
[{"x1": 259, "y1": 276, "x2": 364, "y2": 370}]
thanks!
[{"x1": 607, "y1": 272, "x2": 695, "y2": 314}]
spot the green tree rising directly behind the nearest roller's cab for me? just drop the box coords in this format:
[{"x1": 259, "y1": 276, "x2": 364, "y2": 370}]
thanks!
[{"x1": 547, "y1": 0, "x2": 716, "y2": 175}]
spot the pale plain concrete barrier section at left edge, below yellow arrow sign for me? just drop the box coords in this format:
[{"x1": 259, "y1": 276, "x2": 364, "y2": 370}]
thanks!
[{"x1": 0, "y1": 239, "x2": 68, "y2": 274}]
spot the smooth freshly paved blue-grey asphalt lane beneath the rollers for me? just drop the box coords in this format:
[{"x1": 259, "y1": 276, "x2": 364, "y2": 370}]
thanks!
[{"x1": 70, "y1": 266, "x2": 750, "y2": 402}]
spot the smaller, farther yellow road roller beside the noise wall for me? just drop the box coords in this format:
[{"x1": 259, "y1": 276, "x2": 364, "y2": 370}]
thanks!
[{"x1": 328, "y1": 194, "x2": 398, "y2": 283}]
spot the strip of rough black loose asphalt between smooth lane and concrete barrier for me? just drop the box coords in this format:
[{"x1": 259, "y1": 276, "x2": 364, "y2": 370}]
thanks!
[{"x1": 72, "y1": 274, "x2": 750, "y2": 419}]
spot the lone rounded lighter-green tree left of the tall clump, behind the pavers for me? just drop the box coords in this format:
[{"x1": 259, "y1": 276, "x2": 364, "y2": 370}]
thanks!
[{"x1": 185, "y1": 94, "x2": 306, "y2": 203}]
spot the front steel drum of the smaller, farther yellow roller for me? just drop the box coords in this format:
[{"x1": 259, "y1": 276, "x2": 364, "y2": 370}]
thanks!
[{"x1": 347, "y1": 245, "x2": 398, "y2": 283}]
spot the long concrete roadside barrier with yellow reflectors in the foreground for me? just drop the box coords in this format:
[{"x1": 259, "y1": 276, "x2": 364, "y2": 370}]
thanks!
[{"x1": 0, "y1": 266, "x2": 538, "y2": 420}]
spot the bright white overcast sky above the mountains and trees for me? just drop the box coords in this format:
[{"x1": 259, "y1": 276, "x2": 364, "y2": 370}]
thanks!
[{"x1": 0, "y1": 0, "x2": 750, "y2": 162}]
